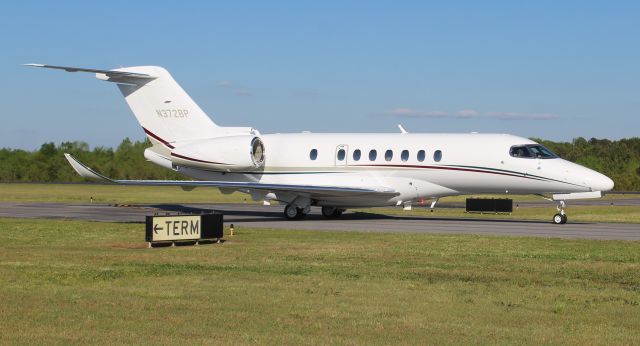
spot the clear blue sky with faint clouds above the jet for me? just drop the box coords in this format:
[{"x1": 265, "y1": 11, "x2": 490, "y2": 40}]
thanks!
[{"x1": 0, "y1": 1, "x2": 640, "y2": 149}]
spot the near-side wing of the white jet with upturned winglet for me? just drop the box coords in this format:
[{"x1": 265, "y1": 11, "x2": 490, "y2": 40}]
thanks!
[{"x1": 64, "y1": 153, "x2": 398, "y2": 198}]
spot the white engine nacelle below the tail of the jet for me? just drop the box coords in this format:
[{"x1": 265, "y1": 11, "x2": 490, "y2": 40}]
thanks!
[{"x1": 171, "y1": 135, "x2": 265, "y2": 172}]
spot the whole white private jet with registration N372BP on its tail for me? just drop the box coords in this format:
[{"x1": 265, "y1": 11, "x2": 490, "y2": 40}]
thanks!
[{"x1": 27, "y1": 64, "x2": 613, "y2": 223}]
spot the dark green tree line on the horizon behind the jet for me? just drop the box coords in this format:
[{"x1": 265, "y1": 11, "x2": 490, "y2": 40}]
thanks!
[{"x1": 0, "y1": 137, "x2": 640, "y2": 191}]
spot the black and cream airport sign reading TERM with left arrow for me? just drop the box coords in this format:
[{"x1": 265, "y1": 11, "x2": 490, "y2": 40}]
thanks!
[{"x1": 145, "y1": 213, "x2": 223, "y2": 247}]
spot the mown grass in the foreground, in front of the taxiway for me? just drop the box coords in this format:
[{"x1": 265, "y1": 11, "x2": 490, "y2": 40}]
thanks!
[{"x1": 0, "y1": 219, "x2": 640, "y2": 345}]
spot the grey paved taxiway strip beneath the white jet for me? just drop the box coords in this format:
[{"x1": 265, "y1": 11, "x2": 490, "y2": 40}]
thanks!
[{"x1": 0, "y1": 202, "x2": 640, "y2": 240}]
